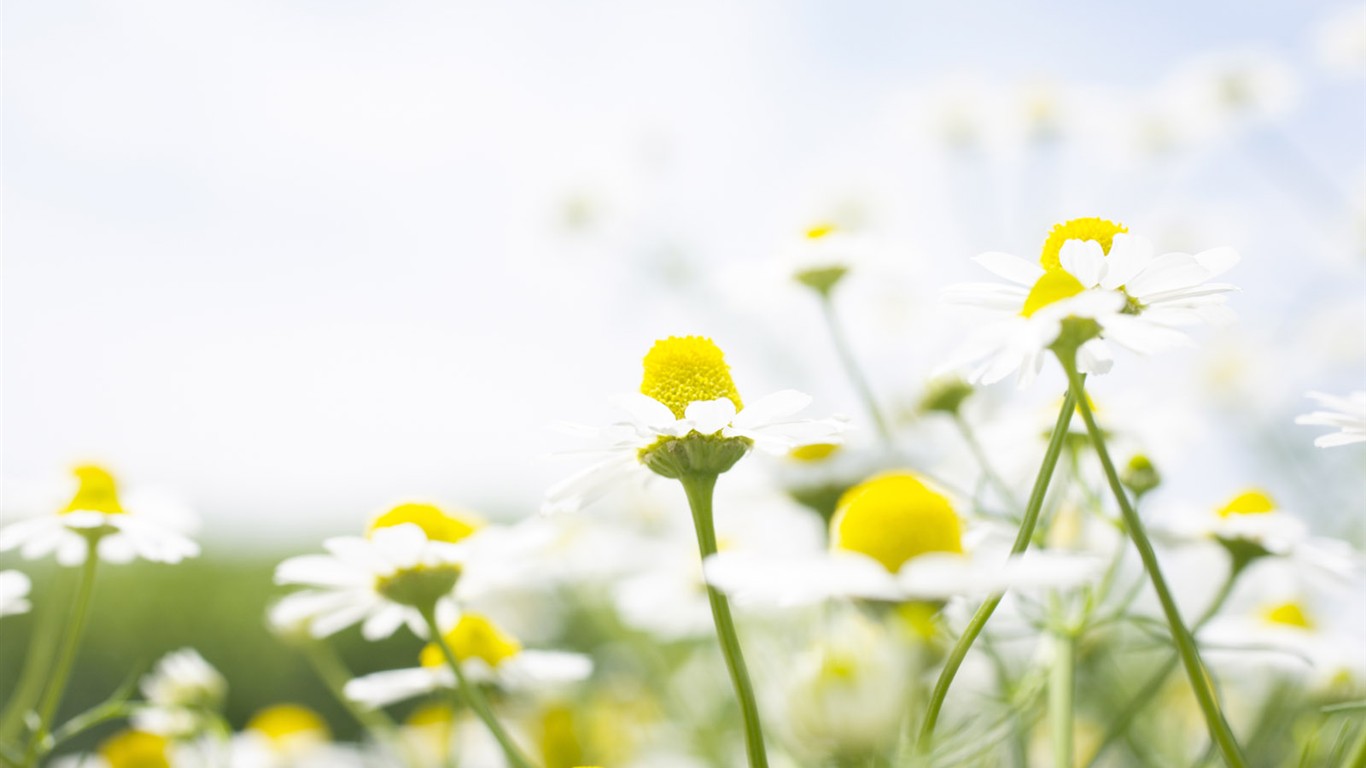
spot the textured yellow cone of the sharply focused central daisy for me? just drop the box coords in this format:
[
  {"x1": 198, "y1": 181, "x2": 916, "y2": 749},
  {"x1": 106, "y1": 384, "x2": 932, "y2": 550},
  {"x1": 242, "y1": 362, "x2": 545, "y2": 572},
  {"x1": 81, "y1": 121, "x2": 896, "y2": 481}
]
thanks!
[{"x1": 641, "y1": 336, "x2": 744, "y2": 418}]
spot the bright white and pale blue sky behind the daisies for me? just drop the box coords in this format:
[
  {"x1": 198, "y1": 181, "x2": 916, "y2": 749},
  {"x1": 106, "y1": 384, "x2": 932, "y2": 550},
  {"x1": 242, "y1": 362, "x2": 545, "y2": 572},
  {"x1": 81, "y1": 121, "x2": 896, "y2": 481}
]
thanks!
[{"x1": 0, "y1": 0, "x2": 1366, "y2": 540}]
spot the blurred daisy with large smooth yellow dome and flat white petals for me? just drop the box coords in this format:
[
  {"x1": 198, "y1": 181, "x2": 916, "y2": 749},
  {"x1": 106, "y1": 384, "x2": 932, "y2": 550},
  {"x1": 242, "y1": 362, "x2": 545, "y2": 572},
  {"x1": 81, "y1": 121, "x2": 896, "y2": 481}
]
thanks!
[{"x1": 706, "y1": 471, "x2": 1098, "y2": 605}]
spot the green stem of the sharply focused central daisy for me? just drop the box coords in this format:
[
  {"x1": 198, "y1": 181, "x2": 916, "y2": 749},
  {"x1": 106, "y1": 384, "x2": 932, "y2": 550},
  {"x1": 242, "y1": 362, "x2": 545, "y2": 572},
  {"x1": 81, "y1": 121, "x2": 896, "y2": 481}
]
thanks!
[{"x1": 679, "y1": 473, "x2": 768, "y2": 768}]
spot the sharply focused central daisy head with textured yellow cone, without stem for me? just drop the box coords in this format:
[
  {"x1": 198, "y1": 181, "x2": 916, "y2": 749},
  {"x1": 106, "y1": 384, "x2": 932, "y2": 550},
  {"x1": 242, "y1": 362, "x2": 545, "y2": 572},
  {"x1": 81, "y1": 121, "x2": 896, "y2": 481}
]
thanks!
[{"x1": 544, "y1": 336, "x2": 844, "y2": 512}]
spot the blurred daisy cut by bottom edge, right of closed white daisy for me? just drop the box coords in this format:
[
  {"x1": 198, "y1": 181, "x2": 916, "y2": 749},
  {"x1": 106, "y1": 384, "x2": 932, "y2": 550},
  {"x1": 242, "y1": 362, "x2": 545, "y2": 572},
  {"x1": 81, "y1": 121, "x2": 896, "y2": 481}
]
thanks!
[{"x1": 228, "y1": 704, "x2": 366, "y2": 768}]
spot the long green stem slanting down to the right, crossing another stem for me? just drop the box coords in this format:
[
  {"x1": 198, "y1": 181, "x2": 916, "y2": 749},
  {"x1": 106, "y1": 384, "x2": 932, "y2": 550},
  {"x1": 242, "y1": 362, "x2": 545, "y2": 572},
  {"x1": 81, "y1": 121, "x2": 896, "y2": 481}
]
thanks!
[{"x1": 1057, "y1": 348, "x2": 1247, "y2": 768}]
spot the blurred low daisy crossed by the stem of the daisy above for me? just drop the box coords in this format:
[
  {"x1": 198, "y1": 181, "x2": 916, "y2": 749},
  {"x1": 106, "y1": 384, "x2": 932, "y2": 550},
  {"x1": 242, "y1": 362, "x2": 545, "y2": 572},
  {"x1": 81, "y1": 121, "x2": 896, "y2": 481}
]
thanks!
[{"x1": 346, "y1": 614, "x2": 593, "y2": 707}]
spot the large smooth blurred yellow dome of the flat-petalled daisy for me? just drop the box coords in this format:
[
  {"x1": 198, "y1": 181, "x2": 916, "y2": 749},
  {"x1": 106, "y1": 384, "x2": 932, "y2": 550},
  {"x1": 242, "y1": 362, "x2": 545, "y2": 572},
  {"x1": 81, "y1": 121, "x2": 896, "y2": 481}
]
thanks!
[{"x1": 831, "y1": 471, "x2": 963, "y2": 573}]
